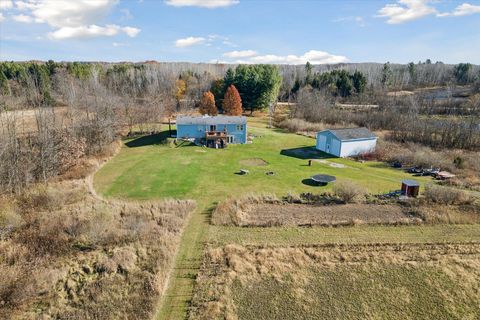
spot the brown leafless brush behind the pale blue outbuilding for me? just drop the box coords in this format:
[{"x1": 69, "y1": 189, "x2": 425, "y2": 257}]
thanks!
[{"x1": 291, "y1": 88, "x2": 480, "y2": 150}]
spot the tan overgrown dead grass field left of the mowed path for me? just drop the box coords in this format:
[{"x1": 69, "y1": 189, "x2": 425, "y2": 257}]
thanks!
[{"x1": 0, "y1": 181, "x2": 195, "y2": 319}]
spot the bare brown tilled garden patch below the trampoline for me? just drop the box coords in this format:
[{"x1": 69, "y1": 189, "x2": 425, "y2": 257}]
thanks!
[{"x1": 242, "y1": 203, "x2": 414, "y2": 226}]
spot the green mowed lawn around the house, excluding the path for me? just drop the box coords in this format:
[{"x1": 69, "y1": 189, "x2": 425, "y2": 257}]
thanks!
[{"x1": 95, "y1": 122, "x2": 432, "y2": 203}]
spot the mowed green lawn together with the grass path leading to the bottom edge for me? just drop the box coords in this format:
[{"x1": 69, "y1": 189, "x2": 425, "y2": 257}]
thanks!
[{"x1": 94, "y1": 119, "x2": 436, "y2": 319}]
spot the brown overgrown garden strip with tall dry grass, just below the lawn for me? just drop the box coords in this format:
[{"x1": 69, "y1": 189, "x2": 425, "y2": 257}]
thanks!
[{"x1": 211, "y1": 192, "x2": 480, "y2": 227}]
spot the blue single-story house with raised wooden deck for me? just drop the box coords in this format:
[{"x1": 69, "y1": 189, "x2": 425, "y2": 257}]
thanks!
[{"x1": 176, "y1": 115, "x2": 247, "y2": 148}]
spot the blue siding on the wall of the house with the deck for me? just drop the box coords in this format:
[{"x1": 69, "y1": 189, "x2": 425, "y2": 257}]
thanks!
[{"x1": 177, "y1": 123, "x2": 247, "y2": 143}]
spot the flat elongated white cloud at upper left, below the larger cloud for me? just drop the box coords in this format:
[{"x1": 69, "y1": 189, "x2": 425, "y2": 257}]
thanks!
[{"x1": 48, "y1": 24, "x2": 140, "y2": 40}]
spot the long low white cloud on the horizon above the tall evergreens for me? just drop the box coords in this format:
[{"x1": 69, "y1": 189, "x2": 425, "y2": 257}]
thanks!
[{"x1": 224, "y1": 50, "x2": 348, "y2": 64}]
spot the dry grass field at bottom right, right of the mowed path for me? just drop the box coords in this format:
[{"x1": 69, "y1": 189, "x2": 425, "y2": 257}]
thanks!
[{"x1": 190, "y1": 244, "x2": 480, "y2": 319}]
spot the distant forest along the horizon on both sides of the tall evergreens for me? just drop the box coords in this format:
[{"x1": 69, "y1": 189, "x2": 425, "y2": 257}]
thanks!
[{"x1": 0, "y1": 60, "x2": 480, "y2": 111}]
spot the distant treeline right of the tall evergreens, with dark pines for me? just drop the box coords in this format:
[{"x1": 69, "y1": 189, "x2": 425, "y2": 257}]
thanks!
[{"x1": 282, "y1": 60, "x2": 480, "y2": 100}]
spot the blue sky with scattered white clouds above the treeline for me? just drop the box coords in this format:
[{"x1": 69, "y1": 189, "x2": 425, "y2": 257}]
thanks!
[{"x1": 0, "y1": 0, "x2": 480, "y2": 64}]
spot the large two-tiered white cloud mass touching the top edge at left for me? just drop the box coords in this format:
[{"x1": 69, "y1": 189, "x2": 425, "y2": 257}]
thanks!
[{"x1": 9, "y1": 0, "x2": 140, "y2": 40}]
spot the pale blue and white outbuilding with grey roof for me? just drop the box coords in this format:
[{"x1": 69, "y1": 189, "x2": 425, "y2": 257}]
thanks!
[{"x1": 316, "y1": 128, "x2": 377, "y2": 158}]
